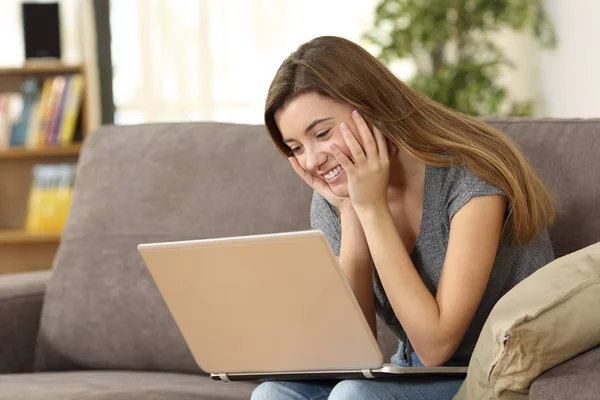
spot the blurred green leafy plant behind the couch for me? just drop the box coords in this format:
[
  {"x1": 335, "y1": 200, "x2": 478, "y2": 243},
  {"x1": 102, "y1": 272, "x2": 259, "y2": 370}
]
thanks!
[{"x1": 364, "y1": 0, "x2": 556, "y2": 116}]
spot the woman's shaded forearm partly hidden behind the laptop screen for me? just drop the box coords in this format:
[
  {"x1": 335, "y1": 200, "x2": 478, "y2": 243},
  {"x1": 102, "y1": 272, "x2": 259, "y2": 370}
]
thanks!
[{"x1": 339, "y1": 210, "x2": 377, "y2": 336}]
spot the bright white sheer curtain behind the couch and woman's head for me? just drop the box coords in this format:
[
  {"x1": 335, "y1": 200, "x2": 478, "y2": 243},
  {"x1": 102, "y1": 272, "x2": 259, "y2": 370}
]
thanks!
[{"x1": 110, "y1": 0, "x2": 375, "y2": 124}]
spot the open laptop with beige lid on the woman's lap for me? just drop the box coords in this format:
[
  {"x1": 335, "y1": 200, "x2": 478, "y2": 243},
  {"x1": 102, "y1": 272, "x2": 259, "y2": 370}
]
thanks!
[{"x1": 138, "y1": 230, "x2": 467, "y2": 381}]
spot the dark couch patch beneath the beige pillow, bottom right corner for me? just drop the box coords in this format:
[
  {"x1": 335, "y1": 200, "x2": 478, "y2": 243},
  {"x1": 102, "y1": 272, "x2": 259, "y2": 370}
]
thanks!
[{"x1": 529, "y1": 346, "x2": 600, "y2": 400}]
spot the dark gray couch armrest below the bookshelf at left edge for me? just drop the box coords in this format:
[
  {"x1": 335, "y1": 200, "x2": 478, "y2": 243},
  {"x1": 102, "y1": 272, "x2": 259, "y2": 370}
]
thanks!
[{"x1": 0, "y1": 271, "x2": 51, "y2": 374}]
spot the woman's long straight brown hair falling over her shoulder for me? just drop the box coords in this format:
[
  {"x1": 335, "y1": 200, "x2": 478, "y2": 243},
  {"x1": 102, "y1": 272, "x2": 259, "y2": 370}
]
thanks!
[{"x1": 265, "y1": 36, "x2": 554, "y2": 245}]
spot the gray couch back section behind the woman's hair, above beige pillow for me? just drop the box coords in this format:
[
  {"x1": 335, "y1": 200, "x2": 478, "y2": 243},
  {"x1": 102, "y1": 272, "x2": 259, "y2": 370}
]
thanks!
[{"x1": 484, "y1": 118, "x2": 600, "y2": 257}]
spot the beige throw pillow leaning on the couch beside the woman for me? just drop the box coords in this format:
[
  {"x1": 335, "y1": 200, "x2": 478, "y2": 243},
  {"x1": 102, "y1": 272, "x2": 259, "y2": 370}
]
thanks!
[{"x1": 455, "y1": 242, "x2": 600, "y2": 400}]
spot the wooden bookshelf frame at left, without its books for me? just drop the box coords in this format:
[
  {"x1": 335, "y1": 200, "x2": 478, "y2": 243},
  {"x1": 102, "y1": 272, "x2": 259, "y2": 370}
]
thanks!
[{"x1": 0, "y1": 63, "x2": 90, "y2": 274}]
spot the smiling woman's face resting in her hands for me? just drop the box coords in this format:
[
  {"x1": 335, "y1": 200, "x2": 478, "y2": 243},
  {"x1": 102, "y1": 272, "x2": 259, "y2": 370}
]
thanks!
[{"x1": 275, "y1": 93, "x2": 362, "y2": 196}]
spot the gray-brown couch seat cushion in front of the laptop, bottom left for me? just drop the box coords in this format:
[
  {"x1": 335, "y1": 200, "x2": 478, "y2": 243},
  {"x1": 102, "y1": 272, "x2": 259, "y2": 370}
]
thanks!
[{"x1": 0, "y1": 371, "x2": 256, "y2": 400}]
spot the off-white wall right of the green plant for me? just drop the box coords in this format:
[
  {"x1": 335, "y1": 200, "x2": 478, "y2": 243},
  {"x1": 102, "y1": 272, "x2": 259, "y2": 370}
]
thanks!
[{"x1": 482, "y1": 0, "x2": 600, "y2": 118}]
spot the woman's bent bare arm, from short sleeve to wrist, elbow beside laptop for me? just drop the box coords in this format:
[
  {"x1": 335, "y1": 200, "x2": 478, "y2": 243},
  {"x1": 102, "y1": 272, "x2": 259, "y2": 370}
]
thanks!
[{"x1": 359, "y1": 196, "x2": 506, "y2": 365}]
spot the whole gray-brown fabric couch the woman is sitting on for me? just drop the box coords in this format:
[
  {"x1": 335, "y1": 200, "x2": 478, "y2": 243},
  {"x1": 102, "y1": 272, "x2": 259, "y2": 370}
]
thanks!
[{"x1": 0, "y1": 119, "x2": 600, "y2": 400}]
